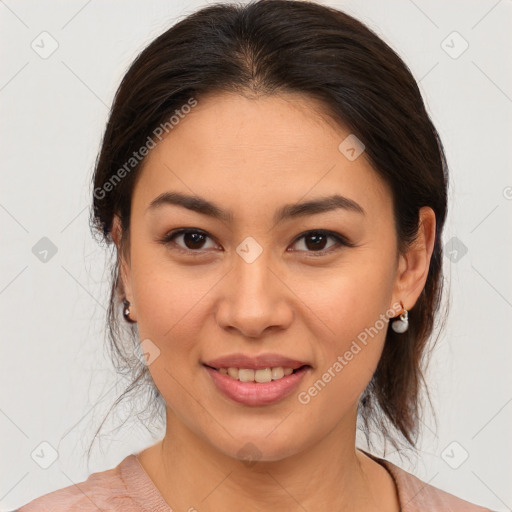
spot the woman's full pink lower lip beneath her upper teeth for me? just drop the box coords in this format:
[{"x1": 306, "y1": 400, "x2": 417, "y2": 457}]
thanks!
[{"x1": 203, "y1": 365, "x2": 311, "y2": 406}]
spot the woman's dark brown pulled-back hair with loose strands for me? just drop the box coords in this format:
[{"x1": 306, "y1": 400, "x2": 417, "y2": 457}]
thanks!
[{"x1": 89, "y1": 0, "x2": 448, "y2": 464}]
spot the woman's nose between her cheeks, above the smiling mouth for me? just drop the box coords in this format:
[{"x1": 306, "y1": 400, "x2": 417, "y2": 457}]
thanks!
[{"x1": 216, "y1": 251, "x2": 293, "y2": 338}]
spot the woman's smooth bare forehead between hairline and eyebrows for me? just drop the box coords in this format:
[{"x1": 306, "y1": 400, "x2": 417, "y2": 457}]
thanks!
[{"x1": 133, "y1": 93, "x2": 391, "y2": 222}]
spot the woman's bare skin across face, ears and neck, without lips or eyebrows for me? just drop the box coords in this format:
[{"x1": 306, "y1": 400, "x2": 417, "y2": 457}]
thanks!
[{"x1": 113, "y1": 93, "x2": 435, "y2": 512}]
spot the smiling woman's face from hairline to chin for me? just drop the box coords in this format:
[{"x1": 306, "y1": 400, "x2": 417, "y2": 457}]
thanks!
[{"x1": 115, "y1": 94, "x2": 430, "y2": 460}]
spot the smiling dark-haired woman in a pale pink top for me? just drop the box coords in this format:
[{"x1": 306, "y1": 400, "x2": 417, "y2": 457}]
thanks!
[{"x1": 15, "y1": 0, "x2": 496, "y2": 512}]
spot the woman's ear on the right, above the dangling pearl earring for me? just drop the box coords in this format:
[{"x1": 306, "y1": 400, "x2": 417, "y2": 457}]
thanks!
[{"x1": 392, "y1": 206, "x2": 436, "y2": 310}]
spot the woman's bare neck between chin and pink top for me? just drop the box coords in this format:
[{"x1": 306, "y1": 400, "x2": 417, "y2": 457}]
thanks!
[{"x1": 138, "y1": 410, "x2": 389, "y2": 512}]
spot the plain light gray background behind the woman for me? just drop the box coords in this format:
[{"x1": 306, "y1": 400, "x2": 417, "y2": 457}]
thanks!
[{"x1": 0, "y1": 0, "x2": 512, "y2": 511}]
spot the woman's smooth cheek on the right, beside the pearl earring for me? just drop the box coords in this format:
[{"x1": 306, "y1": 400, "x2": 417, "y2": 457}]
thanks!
[{"x1": 295, "y1": 252, "x2": 394, "y2": 394}]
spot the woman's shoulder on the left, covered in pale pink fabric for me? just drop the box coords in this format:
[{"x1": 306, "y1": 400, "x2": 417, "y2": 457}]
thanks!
[{"x1": 14, "y1": 455, "x2": 140, "y2": 512}]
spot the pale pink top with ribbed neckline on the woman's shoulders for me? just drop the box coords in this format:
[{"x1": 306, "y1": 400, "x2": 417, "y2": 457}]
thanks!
[{"x1": 14, "y1": 450, "x2": 492, "y2": 512}]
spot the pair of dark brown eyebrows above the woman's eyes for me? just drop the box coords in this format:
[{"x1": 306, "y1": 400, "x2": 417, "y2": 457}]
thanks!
[{"x1": 146, "y1": 192, "x2": 366, "y2": 224}]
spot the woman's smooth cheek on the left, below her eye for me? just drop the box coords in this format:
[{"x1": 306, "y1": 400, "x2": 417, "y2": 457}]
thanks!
[{"x1": 132, "y1": 258, "x2": 218, "y2": 412}]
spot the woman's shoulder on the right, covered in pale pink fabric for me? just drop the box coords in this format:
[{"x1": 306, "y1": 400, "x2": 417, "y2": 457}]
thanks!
[{"x1": 364, "y1": 452, "x2": 492, "y2": 512}]
